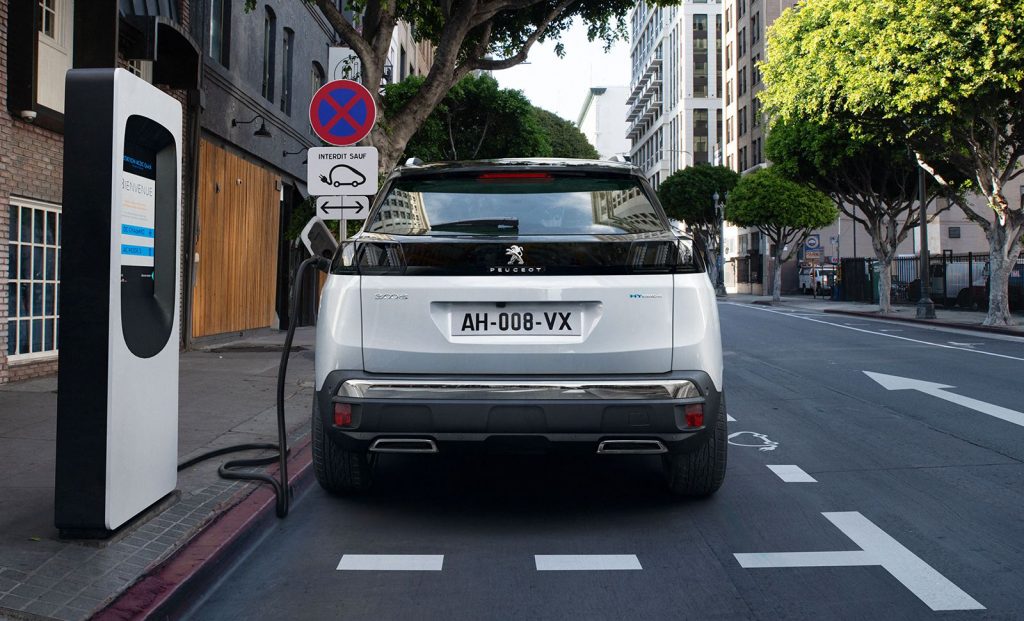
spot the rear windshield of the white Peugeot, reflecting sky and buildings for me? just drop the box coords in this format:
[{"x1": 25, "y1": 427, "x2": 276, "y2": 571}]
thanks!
[{"x1": 366, "y1": 172, "x2": 666, "y2": 236}]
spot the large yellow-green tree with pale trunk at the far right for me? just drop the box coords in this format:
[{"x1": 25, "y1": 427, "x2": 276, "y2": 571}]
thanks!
[{"x1": 761, "y1": 0, "x2": 1024, "y2": 325}]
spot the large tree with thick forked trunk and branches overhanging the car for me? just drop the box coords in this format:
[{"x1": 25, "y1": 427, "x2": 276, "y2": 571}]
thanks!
[{"x1": 246, "y1": 0, "x2": 680, "y2": 171}]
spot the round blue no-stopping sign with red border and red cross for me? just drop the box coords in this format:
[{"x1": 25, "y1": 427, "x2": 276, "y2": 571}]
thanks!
[{"x1": 309, "y1": 80, "x2": 377, "y2": 147}]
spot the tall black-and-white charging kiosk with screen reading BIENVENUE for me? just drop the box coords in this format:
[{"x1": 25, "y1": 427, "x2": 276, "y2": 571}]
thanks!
[{"x1": 54, "y1": 69, "x2": 182, "y2": 536}]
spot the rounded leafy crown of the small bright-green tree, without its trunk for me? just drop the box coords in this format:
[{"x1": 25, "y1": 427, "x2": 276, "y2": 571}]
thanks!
[{"x1": 725, "y1": 168, "x2": 839, "y2": 233}]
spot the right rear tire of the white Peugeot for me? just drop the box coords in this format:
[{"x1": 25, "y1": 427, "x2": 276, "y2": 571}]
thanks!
[{"x1": 662, "y1": 401, "x2": 729, "y2": 498}]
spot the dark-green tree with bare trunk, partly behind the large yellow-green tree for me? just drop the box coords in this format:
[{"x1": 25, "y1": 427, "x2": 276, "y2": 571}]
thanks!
[{"x1": 765, "y1": 117, "x2": 948, "y2": 313}]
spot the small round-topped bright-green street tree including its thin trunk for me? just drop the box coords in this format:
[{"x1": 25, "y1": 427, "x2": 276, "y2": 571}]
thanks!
[{"x1": 725, "y1": 167, "x2": 839, "y2": 302}]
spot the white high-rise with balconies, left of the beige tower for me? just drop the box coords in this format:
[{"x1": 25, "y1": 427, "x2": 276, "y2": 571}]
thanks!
[{"x1": 626, "y1": 1, "x2": 724, "y2": 188}]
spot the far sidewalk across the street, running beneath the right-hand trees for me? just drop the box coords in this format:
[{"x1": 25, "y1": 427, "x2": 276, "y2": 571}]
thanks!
[{"x1": 719, "y1": 293, "x2": 1024, "y2": 336}]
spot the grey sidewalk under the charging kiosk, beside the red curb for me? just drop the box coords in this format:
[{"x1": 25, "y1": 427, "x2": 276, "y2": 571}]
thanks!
[{"x1": 0, "y1": 328, "x2": 314, "y2": 620}]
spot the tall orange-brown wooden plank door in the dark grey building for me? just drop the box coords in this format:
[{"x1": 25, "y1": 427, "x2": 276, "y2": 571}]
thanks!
[{"x1": 193, "y1": 140, "x2": 281, "y2": 338}]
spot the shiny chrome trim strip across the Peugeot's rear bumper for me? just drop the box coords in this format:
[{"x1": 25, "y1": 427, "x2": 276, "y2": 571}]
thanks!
[{"x1": 338, "y1": 379, "x2": 701, "y2": 401}]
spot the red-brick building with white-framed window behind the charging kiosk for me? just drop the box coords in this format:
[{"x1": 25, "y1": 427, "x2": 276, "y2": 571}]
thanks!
[{"x1": 0, "y1": 0, "x2": 200, "y2": 382}]
